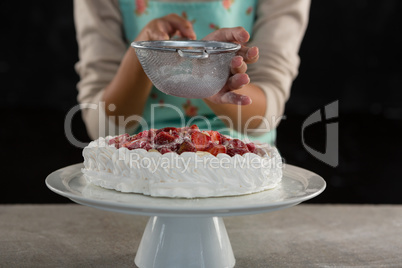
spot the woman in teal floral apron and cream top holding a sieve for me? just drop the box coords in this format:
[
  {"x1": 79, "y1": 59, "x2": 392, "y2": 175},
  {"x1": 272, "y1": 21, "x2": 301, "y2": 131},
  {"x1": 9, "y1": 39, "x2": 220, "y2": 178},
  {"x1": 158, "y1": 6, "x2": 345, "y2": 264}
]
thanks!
[{"x1": 75, "y1": 0, "x2": 310, "y2": 143}]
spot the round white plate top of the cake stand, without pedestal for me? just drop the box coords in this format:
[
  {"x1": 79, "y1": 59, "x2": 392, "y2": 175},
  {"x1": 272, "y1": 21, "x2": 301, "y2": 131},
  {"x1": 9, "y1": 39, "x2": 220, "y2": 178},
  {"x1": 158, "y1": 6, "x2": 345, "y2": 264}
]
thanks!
[{"x1": 46, "y1": 164, "x2": 326, "y2": 217}]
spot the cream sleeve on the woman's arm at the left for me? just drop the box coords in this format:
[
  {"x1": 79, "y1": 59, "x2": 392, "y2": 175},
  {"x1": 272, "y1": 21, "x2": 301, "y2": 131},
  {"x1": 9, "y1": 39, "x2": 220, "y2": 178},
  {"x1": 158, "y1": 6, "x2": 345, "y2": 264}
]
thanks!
[{"x1": 74, "y1": 0, "x2": 127, "y2": 139}]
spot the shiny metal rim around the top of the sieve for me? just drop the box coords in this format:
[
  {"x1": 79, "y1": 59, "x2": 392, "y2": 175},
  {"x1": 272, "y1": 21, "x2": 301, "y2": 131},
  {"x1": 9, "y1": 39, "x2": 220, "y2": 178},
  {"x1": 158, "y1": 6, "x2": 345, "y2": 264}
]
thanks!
[{"x1": 131, "y1": 40, "x2": 241, "y2": 54}]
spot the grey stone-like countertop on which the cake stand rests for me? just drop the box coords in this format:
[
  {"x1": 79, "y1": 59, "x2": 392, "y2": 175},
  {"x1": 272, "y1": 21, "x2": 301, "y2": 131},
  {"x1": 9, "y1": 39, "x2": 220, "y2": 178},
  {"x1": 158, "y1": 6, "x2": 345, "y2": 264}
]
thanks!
[{"x1": 0, "y1": 204, "x2": 402, "y2": 267}]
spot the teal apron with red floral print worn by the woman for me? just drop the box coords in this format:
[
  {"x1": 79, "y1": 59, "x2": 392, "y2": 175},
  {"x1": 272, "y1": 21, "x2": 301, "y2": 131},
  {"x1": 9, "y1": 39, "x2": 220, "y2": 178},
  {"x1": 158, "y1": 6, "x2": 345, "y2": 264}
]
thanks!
[{"x1": 119, "y1": 0, "x2": 276, "y2": 143}]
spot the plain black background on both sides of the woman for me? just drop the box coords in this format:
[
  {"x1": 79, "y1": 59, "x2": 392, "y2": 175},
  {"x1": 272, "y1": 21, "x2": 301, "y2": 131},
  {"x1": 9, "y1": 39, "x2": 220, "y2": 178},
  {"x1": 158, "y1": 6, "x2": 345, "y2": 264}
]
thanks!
[{"x1": 0, "y1": 0, "x2": 402, "y2": 204}]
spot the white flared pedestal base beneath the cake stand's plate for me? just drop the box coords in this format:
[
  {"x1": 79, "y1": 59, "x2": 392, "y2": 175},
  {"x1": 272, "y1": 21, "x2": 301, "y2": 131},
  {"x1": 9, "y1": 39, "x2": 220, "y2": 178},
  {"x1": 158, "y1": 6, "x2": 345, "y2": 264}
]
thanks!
[{"x1": 135, "y1": 216, "x2": 235, "y2": 268}]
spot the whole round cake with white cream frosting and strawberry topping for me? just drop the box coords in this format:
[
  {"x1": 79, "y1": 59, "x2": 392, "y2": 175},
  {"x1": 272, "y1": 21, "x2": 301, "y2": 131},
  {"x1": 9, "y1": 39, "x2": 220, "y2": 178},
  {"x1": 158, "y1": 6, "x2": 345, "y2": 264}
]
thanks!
[{"x1": 82, "y1": 125, "x2": 282, "y2": 198}]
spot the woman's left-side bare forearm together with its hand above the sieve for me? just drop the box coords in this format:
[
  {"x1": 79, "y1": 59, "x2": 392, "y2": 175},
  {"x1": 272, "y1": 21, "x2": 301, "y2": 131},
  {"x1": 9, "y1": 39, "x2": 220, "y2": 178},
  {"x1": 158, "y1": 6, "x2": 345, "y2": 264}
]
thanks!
[{"x1": 102, "y1": 14, "x2": 196, "y2": 127}]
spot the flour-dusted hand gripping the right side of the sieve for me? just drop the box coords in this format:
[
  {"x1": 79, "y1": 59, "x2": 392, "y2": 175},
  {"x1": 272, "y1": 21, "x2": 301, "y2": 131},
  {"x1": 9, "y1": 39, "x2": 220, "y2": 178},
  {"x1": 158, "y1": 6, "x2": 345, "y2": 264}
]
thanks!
[{"x1": 204, "y1": 27, "x2": 259, "y2": 105}]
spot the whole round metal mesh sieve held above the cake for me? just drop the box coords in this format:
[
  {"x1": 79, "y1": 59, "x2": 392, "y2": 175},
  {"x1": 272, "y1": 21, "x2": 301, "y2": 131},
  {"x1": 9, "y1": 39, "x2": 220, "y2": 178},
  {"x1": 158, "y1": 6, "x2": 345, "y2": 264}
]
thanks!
[{"x1": 131, "y1": 40, "x2": 240, "y2": 98}]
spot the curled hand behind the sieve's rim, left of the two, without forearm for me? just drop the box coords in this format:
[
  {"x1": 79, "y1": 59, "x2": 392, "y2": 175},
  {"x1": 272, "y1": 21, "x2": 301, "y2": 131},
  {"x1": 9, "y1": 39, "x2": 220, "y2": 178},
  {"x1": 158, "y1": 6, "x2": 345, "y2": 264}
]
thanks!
[{"x1": 135, "y1": 14, "x2": 196, "y2": 41}]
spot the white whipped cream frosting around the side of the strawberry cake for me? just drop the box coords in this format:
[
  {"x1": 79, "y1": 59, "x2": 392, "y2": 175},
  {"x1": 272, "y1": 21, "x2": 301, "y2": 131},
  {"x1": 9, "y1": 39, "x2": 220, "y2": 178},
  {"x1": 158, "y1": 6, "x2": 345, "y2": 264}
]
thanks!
[{"x1": 82, "y1": 136, "x2": 282, "y2": 198}]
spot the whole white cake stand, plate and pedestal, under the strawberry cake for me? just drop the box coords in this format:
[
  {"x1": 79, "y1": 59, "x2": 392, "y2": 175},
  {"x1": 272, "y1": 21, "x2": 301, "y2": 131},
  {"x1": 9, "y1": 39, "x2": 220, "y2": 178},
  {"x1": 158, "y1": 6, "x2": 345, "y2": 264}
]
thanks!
[{"x1": 46, "y1": 164, "x2": 326, "y2": 268}]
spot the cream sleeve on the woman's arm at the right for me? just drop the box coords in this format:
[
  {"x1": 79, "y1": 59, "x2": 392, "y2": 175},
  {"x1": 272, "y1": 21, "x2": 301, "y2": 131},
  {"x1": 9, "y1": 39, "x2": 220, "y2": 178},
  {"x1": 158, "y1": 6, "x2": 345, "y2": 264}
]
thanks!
[{"x1": 247, "y1": 0, "x2": 310, "y2": 134}]
